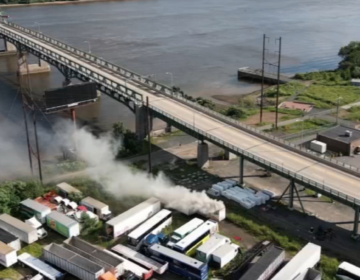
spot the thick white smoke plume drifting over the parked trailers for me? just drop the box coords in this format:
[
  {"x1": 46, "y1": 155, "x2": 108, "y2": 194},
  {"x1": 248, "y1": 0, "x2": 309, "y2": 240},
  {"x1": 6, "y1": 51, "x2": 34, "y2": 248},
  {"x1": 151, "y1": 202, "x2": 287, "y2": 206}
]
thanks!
[{"x1": 57, "y1": 121, "x2": 224, "y2": 214}]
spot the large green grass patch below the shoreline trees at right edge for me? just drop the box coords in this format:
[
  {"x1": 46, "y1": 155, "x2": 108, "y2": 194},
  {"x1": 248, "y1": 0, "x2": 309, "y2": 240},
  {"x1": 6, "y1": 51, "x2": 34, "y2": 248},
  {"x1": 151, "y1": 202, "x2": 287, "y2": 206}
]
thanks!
[{"x1": 297, "y1": 85, "x2": 360, "y2": 109}]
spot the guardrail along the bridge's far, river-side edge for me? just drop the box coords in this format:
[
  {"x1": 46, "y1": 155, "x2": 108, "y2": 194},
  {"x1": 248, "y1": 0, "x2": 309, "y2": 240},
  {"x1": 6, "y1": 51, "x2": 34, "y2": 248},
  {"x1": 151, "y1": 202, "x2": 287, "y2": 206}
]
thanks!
[{"x1": 5, "y1": 21, "x2": 360, "y2": 176}]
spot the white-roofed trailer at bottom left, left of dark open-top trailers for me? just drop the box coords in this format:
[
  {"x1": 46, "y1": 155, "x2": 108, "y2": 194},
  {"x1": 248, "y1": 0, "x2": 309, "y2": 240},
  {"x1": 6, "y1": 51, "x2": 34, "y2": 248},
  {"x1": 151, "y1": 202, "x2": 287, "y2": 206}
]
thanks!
[{"x1": 18, "y1": 253, "x2": 65, "y2": 280}]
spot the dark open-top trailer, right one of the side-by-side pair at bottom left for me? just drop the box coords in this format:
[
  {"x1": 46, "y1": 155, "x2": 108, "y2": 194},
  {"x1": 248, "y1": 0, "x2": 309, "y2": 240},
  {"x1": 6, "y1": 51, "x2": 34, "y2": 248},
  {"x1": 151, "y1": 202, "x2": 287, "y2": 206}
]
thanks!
[{"x1": 63, "y1": 237, "x2": 124, "y2": 277}]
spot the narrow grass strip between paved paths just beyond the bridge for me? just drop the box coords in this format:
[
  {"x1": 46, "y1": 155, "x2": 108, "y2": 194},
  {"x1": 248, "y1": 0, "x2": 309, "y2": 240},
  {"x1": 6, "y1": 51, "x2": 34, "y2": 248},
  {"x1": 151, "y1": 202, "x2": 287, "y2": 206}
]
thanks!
[{"x1": 265, "y1": 119, "x2": 333, "y2": 134}]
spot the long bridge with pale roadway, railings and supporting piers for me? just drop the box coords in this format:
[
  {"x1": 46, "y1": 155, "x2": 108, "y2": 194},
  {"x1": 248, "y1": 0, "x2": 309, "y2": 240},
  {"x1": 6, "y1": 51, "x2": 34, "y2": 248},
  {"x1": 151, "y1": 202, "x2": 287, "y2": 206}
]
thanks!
[{"x1": 0, "y1": 21, "x2": 360, "y2": 234}]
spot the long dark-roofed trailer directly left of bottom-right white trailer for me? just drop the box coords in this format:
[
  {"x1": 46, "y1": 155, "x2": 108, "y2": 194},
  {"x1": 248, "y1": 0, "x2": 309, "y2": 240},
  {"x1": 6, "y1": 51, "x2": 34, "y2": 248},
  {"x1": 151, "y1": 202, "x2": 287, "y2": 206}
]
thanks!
[{"x1": 239, "y1": 246, "x2": 288, "y2": 280}]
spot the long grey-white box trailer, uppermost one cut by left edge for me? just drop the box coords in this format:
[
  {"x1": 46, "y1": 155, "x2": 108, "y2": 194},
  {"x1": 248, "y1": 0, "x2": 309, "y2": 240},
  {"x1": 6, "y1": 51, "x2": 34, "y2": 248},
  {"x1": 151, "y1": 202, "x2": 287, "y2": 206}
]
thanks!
[{"x1": 0, "y1": 214, "x2": 38, "y2": 244}]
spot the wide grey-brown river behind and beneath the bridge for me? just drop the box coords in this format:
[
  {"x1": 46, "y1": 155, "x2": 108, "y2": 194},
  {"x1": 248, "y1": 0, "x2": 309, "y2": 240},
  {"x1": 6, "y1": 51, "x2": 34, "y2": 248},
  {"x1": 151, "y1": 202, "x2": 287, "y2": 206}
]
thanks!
[{"x1": 0, "y1": 0, "x2": 360, "y2": 128}]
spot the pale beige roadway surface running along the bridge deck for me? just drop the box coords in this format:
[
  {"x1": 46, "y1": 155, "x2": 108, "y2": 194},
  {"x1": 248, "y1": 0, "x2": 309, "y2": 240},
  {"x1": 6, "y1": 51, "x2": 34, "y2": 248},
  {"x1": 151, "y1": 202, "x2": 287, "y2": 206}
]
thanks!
[{"x1": 1, "y1": 24, "x2": 360, "y2": 199}]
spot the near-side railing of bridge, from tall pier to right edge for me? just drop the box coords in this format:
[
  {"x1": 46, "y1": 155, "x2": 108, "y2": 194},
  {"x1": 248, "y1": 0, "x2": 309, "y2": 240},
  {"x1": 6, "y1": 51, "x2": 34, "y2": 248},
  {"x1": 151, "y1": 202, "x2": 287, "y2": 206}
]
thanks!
[{"x1": 150, "y1": 105, "x2": 360, "y2": 205}]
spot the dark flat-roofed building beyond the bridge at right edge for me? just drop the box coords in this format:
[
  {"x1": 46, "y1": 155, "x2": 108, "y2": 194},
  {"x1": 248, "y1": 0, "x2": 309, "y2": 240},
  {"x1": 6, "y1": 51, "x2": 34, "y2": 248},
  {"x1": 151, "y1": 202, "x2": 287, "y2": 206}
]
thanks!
[{"x1": 316, "y1": 125, "x2": 360, "y2": 156}]
